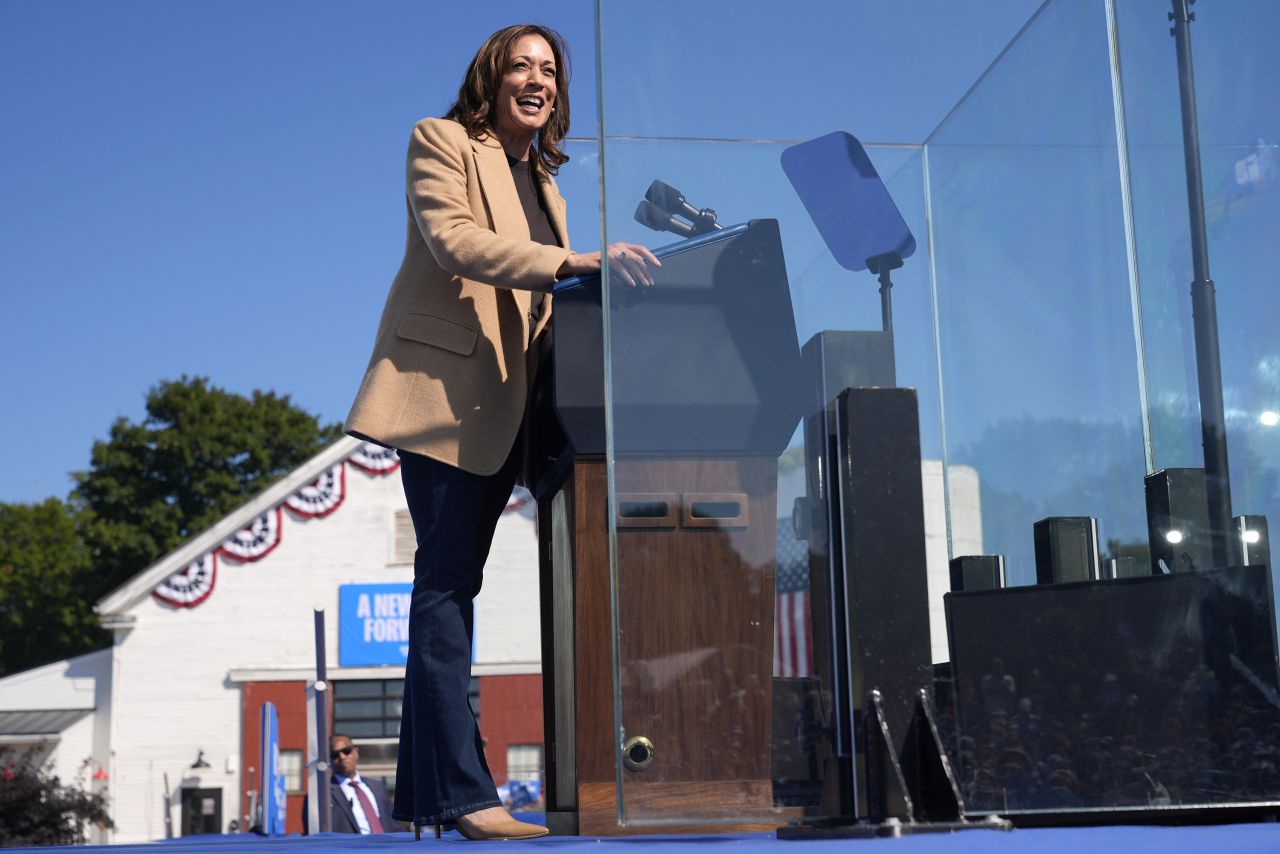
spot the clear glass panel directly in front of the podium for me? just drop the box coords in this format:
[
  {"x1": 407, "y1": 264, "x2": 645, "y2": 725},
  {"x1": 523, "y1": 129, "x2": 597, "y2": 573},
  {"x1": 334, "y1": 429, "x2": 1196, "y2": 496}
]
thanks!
[{"x1": 593, "y1": 3, "x2": 962, "y2": 832}]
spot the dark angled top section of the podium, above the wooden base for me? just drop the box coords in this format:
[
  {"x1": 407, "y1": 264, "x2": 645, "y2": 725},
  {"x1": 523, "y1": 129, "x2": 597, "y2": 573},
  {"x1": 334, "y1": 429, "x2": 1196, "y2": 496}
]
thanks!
[{"x1": 553, "y1": 219, "x2": 805, "y2": 457}]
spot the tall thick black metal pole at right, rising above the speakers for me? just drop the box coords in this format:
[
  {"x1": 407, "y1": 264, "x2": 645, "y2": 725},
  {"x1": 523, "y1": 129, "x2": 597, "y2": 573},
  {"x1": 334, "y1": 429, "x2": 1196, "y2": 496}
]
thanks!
[{"x1": 1169, "y1": 0, "x2": 1231, "y2": 566}]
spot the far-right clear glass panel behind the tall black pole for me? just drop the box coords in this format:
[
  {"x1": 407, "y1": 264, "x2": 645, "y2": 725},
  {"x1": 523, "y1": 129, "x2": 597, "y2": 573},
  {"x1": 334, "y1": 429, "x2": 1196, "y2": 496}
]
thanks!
[{"x1": 1115, "y1": 0, "x2": 1280, "y2": 581}]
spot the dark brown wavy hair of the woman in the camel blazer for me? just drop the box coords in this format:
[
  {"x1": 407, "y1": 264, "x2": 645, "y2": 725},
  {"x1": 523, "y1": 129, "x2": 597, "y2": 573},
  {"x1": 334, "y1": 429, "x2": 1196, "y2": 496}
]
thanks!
[{"x1": 444, "y1": 24, "x2": 570, "y2": 175}]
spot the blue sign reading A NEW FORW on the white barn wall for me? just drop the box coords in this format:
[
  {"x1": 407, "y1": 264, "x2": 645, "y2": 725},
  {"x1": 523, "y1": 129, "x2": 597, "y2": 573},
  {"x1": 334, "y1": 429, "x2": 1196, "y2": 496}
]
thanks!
[{"x1": 338, "y1": 584, "x2": 413, "y2": 667}]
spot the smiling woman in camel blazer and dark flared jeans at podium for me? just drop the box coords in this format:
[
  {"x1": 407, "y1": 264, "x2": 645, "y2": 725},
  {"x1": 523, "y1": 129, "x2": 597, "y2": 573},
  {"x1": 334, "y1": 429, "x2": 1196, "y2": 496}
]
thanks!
[{"x1": 346, "y1": 24, "x2": 658, "y2": 839}]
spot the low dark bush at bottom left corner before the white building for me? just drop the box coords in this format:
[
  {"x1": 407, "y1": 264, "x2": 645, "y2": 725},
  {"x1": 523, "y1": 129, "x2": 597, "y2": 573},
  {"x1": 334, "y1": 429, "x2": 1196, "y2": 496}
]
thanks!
[{"x1": 0, "y1": 750, "x2": 111, "y2": 848}]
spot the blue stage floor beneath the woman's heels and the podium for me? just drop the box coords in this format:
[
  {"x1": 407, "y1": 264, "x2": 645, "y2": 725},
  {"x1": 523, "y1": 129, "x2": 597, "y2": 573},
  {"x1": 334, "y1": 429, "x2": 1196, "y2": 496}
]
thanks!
[{"x1": 29, "y1": 822, "x2": 1280, "y2": 854}]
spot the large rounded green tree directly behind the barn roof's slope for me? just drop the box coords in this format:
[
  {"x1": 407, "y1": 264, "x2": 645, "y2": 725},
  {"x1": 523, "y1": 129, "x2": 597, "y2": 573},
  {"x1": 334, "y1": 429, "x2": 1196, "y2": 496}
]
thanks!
[{"x1": 72, "y1": 376, "x2": 342, "y2": 598}]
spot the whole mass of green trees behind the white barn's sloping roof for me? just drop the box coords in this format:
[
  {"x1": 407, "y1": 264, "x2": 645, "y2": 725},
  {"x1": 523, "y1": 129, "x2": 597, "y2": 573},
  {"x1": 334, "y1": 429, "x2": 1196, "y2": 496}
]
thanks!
[{"x1": 0, "y1": 376, "x2": 340, "y2": 676}]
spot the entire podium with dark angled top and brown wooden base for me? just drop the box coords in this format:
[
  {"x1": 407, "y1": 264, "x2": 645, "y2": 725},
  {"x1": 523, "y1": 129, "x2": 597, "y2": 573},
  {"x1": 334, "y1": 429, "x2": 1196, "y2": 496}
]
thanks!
[{"x1": 535, "y1": 220, "x2": 803, "y2": 835}]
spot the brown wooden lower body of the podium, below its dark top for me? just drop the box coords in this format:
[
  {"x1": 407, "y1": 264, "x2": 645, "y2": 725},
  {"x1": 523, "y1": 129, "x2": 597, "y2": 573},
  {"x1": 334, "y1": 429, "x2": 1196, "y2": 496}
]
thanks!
[{"x1": 539, "y1": 457, "x2": 781, "y2": 836}]
